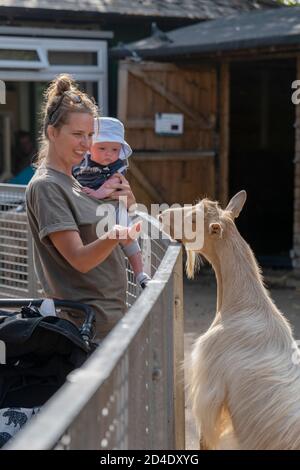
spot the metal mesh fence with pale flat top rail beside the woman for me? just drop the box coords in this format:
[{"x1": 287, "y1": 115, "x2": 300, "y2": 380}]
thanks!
[{"x1": 0, "y1": 185, "x2": 185, "y2": 450}]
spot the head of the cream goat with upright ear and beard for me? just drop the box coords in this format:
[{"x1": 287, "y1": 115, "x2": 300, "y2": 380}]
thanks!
[{"x1": 159, "y1": 191, "x2": 247, "y2": 277}]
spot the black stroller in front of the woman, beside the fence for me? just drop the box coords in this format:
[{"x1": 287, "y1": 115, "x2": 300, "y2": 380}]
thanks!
[{"x1": 0, "y1": 299, "x2": 96, "y2": 447}]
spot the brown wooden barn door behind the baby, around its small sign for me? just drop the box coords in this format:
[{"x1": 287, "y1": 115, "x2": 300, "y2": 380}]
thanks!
[{"x1": 118, "y1": 62, "x2": 217, "y2": 206}]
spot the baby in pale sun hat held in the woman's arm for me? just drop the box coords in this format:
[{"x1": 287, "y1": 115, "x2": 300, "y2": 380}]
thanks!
[{"x1": 73, "y1": 117, "x2": 150, "y2": 289}]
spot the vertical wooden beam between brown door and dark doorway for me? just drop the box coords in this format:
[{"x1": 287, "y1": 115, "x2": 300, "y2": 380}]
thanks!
[{"x1": 218, "y1": 62, "x2": 230, "y2": 207}]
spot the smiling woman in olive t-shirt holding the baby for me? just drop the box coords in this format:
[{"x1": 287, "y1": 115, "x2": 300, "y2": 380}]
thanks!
[{"x1": 26, "y1": 75, "x2": 135, "y2": 338}]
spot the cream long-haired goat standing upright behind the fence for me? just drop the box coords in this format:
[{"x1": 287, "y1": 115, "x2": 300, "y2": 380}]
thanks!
[{"x1": 161, "y1": 191, "x2": 300, "y2": 450}]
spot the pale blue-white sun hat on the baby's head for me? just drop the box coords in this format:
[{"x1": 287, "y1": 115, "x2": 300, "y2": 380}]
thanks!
[{"x1": 93, "y1": 117, "x2": 132, "y2": 160}]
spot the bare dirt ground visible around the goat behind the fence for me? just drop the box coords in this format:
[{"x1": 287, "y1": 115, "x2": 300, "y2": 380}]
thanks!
[{"x1": 184, "y1": 267, "x2": 300, "y2": 450}]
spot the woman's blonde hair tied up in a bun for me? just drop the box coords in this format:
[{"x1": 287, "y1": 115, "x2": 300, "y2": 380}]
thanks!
[{"x1": 35, "y1": 74, "x2": 98, "y2": 167}]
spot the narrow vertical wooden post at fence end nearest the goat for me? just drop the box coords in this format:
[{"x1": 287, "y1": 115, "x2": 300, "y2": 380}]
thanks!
[{"x1": 173, "y1": 250, "x2": 185, "y2": 450}]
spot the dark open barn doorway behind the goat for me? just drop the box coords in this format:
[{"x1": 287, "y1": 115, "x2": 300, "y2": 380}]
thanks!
[{"x1": 229, "y1": 60, "x2": 296, "y2": 268}]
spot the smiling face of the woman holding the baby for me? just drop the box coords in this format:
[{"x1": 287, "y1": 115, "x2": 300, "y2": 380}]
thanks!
[{"x1": 49, "y1": 113, "x2": 94, "y2": 166}]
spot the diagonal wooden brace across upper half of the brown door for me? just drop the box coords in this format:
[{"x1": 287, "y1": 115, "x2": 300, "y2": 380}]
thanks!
[{"x1": 128, "y1": 68, "x2": 214, "y2": 129}]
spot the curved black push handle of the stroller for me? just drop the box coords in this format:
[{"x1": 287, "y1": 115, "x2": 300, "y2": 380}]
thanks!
[{"x1": 0, "y1": 299, "x2": 95, "y2": 347}]
